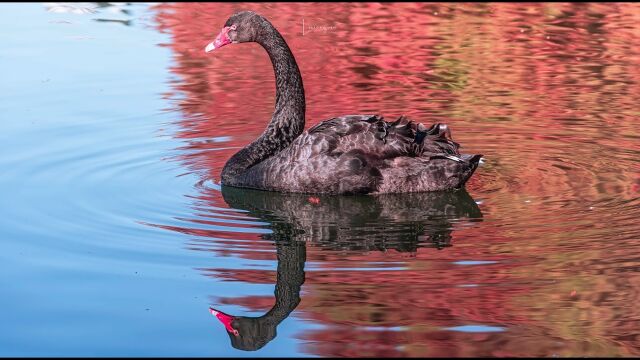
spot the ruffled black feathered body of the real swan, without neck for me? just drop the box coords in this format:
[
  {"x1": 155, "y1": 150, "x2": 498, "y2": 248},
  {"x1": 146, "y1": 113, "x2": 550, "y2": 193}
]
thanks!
[{"x1": 228, "y1": 115, "x2": 482, "y2": 194}]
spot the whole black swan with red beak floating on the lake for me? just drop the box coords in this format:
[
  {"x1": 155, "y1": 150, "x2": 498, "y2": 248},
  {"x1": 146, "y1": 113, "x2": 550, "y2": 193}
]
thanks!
[{"x1": 205, "y1": 11, "x2": 482, "y2": 194}]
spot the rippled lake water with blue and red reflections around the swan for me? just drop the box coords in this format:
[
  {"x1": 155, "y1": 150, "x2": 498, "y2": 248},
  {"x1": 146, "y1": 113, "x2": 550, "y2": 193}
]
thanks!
[{"x1": 0, "y1": 3, "x2": 640, "y2": 357}]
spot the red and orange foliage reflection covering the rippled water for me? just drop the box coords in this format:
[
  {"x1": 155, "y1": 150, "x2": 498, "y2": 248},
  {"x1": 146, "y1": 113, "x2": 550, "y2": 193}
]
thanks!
[{"x1": 154, "y1": 3, "x2": 640, "y2": 356}]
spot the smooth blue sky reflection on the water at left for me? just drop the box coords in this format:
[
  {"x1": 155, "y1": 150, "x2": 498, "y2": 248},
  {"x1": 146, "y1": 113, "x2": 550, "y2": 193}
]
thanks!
[{"x1": 0, "y1": 3, "x2": 300, "y2": 356}]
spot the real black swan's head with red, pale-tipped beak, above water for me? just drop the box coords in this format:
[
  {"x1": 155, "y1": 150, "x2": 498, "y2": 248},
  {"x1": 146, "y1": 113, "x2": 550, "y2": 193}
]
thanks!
[{"x1": 205, "y1": 11, "x2": 266, "y2": 52}]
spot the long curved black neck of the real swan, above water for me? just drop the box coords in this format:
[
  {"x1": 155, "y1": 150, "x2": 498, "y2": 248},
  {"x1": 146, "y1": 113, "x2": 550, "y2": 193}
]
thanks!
[{"x1": 222, "y1": 20, "x2": 305, "y2": 185}]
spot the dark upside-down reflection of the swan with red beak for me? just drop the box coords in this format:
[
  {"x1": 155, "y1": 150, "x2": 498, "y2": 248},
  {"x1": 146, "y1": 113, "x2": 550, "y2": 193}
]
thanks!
[{"x1": 210, "y1": 186, "x2": 482, "y2": 351}]
